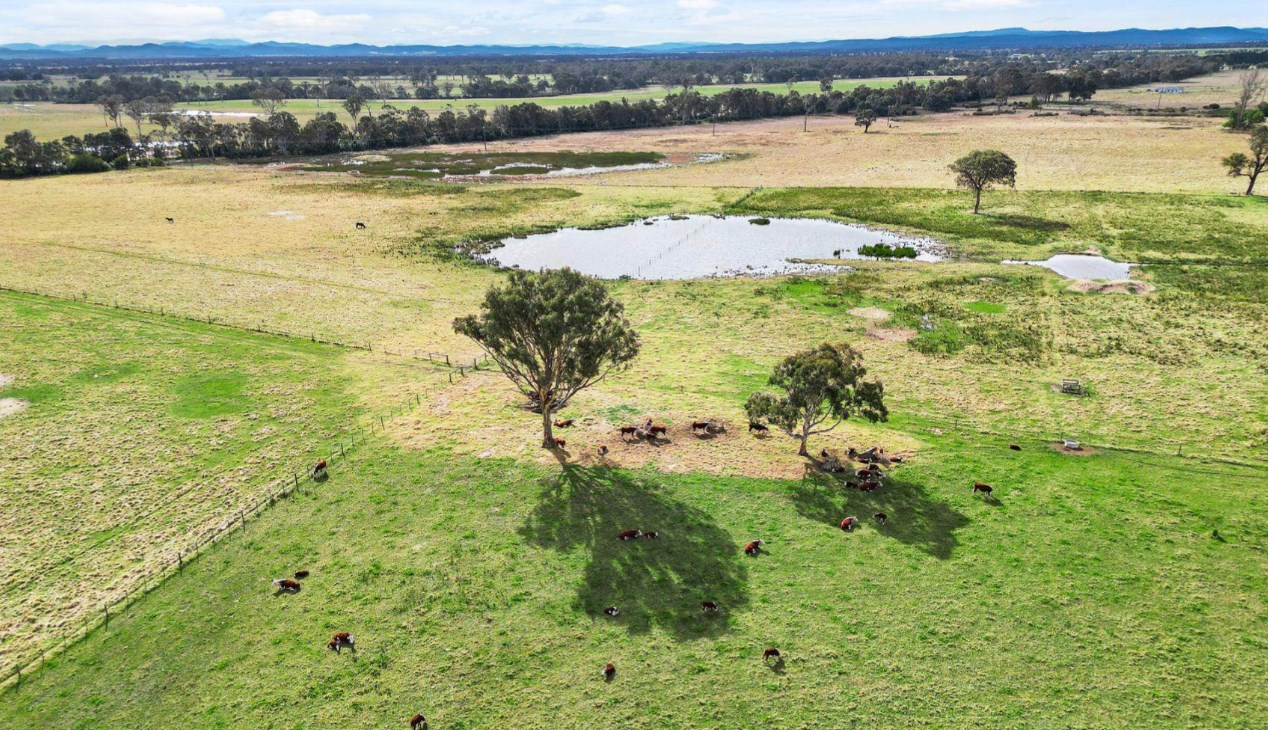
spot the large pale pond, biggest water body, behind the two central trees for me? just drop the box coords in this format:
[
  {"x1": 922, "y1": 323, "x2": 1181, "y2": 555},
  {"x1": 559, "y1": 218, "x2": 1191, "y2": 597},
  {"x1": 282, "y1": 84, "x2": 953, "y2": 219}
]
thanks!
[{"x1": 482, "y1": 215, "x2": 943, "y2": 279}]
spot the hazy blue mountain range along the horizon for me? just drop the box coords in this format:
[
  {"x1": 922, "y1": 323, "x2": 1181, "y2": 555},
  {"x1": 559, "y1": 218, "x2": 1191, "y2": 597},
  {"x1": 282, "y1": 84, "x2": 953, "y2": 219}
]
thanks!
[{"x1": 0, "y1": 27, "x2": 1268, "y2": 61}]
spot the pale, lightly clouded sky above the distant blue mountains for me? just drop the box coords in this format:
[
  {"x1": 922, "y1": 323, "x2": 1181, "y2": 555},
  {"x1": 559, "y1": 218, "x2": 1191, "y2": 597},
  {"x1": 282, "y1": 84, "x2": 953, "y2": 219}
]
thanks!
[{"x1": 0, "y1": 0, "x2": 1268, "y2": 46}]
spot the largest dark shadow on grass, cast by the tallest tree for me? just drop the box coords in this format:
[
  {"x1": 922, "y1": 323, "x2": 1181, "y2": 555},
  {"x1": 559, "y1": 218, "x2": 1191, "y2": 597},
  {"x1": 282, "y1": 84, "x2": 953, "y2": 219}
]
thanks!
[{"x1": 520, "y1": 465, "x2": 748, "y2": 640}]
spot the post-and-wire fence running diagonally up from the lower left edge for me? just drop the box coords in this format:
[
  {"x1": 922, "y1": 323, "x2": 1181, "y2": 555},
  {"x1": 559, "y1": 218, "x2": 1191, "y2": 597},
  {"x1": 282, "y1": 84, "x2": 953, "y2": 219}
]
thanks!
[{"x1": 0, "y1": 382, "x2": 433, "y2": 692}]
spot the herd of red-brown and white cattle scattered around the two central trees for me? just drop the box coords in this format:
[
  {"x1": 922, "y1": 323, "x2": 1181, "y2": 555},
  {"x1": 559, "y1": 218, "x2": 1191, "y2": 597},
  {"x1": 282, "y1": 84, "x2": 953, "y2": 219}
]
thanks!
[{"x1": 280, "y1": 418, "x2": 1021, "y2": 730}]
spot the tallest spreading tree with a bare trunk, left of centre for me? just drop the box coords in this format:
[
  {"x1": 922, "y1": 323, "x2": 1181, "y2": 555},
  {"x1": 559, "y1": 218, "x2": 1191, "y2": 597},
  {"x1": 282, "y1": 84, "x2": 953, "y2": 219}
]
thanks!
[{"x1": 454, "y1": 269, "x2": 639, "y2": 449}]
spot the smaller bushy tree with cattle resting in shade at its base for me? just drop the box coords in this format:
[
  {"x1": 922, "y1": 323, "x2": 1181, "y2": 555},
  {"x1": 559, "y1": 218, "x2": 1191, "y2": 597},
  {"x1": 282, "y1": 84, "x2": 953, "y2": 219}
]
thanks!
[{"x1": 744, "y1": 342, "x2": 889, "y2": 456}]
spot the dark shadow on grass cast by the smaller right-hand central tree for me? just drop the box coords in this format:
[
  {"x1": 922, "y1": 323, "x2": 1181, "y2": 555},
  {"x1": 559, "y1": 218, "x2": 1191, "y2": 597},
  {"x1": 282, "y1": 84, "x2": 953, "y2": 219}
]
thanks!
[{"x1": 790, "y1": 470, "x2": 969, "y2": 560}]
